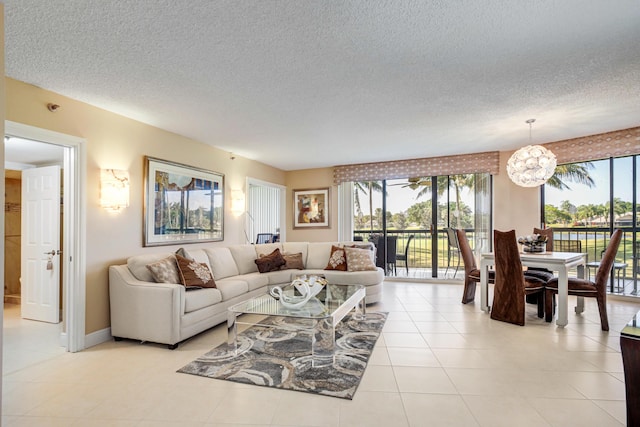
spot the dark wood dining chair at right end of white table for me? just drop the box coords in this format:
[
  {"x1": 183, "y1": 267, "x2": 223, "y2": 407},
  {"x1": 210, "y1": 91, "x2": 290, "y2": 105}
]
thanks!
[{"x1": 545, "y1": 230, "x2": 622, "y2": 331}]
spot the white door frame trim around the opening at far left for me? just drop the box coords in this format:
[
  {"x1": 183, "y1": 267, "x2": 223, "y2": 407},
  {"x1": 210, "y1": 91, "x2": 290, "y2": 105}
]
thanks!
[{"x1": 2, "y1": 120, "x2": 87, "y2": 352}]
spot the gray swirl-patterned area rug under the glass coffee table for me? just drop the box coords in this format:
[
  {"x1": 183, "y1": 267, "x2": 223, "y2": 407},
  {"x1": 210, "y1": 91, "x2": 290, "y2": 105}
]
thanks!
[{"x1": 178, "y1": 312, "x2": 387, "y2": 399}]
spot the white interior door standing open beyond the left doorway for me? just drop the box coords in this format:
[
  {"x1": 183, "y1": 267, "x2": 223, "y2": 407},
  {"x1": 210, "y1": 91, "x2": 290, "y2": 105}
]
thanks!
[{"x1": 20, "y1": 166, "x2": 60, "y2": 323}]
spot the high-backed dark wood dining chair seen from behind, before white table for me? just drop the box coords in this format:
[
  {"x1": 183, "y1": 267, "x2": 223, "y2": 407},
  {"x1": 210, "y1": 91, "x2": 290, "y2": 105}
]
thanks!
[{"x1": 491, "y1": 230, "x2": 545, "y2": 326}]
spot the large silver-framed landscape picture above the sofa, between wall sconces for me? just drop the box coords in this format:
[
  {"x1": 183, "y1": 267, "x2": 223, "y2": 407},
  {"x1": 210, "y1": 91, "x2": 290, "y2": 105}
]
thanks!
[{"x1": 144, "y1": 156, "x2": 224, "y2": 246}]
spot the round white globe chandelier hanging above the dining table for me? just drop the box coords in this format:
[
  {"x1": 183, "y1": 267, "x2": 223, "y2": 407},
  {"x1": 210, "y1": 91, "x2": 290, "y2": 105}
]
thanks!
[{"x1": 507, "y1": 119, "x2": 556, "y2": 187}]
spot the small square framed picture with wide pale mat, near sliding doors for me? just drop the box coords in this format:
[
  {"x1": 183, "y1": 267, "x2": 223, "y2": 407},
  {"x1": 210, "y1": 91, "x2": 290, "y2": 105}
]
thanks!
[{"x1": 293, "y1": 188, "x2": 329, "y2": 228}]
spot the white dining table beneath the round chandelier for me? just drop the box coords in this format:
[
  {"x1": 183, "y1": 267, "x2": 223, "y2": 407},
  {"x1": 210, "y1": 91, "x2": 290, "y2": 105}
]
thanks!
[{"x1": 480, "y1": 252, "x2": 587, "y2": 327}]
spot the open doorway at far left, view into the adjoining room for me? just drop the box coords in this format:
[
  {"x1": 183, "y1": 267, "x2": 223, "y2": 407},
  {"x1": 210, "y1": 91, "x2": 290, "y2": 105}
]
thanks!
[{"x1": 3, "y1": 136, "x2": 67, "y2": 373}]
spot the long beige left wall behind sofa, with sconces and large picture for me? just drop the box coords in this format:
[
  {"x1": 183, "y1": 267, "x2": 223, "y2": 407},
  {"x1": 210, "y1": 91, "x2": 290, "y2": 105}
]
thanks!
[{"x1": 3, "y1": 78, "x2": 285, "y2": 333}]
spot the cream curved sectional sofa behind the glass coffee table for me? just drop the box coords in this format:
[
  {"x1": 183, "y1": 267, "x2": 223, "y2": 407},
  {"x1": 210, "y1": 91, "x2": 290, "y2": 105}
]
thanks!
[{"x1": 109, "y1": 242, "x2": 384, "y2": 349}]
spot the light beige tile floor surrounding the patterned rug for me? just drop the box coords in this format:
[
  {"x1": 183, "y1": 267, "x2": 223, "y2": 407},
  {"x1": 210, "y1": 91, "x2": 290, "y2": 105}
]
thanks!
[{"x1": 2, "y1": 281, "x2": 640, "y2": 427}]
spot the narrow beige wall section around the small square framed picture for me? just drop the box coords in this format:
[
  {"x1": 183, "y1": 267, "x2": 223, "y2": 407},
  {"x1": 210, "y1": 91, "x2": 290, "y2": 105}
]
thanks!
[{"x1": 286, "y1": 168, "x2": 338, "y2": 242}]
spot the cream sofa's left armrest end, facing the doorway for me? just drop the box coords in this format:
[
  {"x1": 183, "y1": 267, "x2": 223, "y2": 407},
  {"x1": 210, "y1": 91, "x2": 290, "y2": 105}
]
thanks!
[{"x1": 109, "y1": 265, "x2": 185, "y2": 344}]
